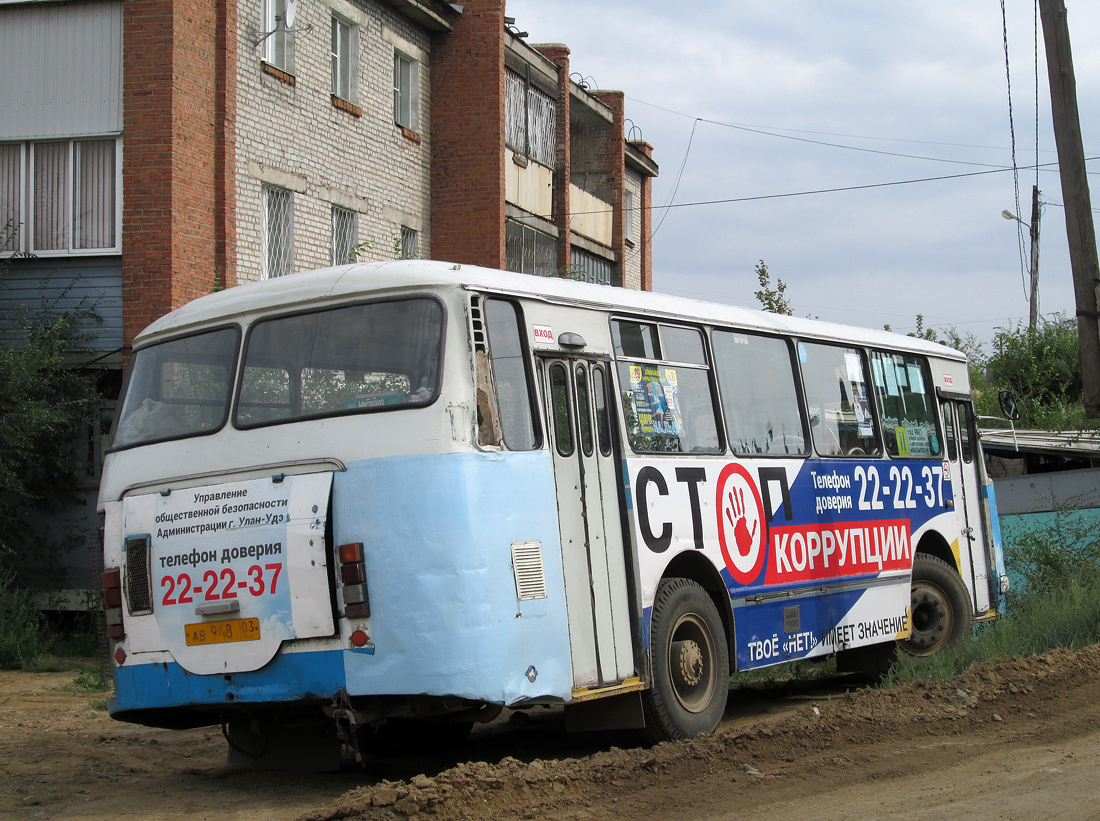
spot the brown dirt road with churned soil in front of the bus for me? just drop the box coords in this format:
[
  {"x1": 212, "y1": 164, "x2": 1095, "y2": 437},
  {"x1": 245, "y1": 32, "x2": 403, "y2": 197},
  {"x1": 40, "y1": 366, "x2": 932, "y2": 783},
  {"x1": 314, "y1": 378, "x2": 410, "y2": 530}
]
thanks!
[{"x1": 0, "y1": 646, "x2": 1100, "y2": 821}]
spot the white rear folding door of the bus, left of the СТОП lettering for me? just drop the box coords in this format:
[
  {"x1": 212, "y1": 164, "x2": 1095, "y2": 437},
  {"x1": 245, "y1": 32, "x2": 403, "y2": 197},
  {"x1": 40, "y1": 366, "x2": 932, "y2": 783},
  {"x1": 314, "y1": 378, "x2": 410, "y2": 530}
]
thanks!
[{"x1": 540, "y1": 358, "x2": 635, "y2": 689}]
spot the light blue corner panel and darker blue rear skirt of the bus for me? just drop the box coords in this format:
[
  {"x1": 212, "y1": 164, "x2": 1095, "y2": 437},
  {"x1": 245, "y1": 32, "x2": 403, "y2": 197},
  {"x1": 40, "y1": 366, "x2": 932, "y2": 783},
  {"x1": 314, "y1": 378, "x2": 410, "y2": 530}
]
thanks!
[{"x1": 111, "y1": 451, "x2": 572, "y2": 723}]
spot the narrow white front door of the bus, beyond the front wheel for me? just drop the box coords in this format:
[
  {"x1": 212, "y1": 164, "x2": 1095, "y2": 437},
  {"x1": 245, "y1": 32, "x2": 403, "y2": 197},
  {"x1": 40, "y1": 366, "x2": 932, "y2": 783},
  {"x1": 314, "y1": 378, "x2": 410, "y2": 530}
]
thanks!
[{"x1": 943, "y1": 398, "x2": 991, "y2": 612}]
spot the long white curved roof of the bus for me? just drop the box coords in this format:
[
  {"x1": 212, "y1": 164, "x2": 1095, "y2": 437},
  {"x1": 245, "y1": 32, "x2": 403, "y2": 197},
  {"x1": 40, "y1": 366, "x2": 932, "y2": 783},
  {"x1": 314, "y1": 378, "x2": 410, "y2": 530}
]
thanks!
[{"x1": 134, "y1": 260, "x2": 965, "y2": 360}]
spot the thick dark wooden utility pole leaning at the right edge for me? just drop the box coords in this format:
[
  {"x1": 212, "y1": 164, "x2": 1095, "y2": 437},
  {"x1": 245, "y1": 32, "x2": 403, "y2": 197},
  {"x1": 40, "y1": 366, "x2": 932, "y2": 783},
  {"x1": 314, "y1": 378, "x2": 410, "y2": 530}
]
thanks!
[{"x1": 1032, "y1": 0, "x2": 1100, "y2": 419}]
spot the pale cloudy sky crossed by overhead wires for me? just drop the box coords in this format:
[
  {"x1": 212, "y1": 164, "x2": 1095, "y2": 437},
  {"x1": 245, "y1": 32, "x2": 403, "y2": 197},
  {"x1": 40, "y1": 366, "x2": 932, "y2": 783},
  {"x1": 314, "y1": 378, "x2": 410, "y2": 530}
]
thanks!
[{"x1": 507, "y1": 0, "x2": 1100, "y2": 349}]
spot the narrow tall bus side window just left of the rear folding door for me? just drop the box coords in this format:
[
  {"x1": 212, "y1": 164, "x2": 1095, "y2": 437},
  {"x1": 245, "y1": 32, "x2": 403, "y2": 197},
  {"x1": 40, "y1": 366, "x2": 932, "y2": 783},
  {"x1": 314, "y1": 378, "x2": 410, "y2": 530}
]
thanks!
[{"x1": 485, "y1": 299, "x2": 539, "y2": 450}]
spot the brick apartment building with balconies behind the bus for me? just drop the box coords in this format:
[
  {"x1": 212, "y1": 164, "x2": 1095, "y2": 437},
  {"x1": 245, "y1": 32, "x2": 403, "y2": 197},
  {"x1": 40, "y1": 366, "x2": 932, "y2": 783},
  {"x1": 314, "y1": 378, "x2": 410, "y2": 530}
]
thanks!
[{"x1": 0, "y1": 0, "x2": 658, "y2": 594}]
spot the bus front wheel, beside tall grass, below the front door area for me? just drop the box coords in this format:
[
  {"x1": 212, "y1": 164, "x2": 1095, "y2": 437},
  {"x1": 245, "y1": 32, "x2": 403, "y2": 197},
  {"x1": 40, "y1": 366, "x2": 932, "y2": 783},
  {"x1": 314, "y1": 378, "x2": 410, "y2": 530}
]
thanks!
[{"x1": 898, "y1": 554, "x2": 974, "y2": 657}]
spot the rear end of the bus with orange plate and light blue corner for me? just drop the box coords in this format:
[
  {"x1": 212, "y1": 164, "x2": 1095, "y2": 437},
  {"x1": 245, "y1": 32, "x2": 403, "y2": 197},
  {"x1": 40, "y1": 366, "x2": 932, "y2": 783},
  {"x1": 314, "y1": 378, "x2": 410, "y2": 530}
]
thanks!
[{"x1": 100, "y1": 272, "x2": 571, "y2": 768}]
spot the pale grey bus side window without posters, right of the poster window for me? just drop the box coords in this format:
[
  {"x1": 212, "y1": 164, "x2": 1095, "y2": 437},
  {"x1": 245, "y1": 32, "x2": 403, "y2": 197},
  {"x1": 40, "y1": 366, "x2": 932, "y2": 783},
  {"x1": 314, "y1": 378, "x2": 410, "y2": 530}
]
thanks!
[{"x1": 711, "y1": 330, "x2": 807, "y2": 456}]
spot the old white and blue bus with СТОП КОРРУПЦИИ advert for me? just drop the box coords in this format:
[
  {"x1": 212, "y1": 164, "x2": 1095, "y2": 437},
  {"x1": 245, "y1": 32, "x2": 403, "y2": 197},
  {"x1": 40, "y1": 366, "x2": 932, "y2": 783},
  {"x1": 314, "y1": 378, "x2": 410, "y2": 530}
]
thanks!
[{"x1": 100, "y1": 261, "x2": 1007, "y2": 755}]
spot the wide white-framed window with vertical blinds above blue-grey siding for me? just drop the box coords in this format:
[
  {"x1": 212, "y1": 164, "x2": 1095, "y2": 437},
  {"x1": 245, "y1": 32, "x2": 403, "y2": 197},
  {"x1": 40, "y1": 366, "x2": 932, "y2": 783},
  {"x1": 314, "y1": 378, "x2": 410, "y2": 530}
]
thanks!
[{"x1": 0, "y1": 136, "x2": 122, "y2": 256}]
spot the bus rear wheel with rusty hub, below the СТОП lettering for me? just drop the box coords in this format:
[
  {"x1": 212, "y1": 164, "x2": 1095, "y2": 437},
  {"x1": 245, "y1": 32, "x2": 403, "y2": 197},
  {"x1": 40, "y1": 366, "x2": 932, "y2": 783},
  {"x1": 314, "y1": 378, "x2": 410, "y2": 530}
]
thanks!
[{"x1": 642, "y1": 579, "x2": 729, "y2": 743}]
